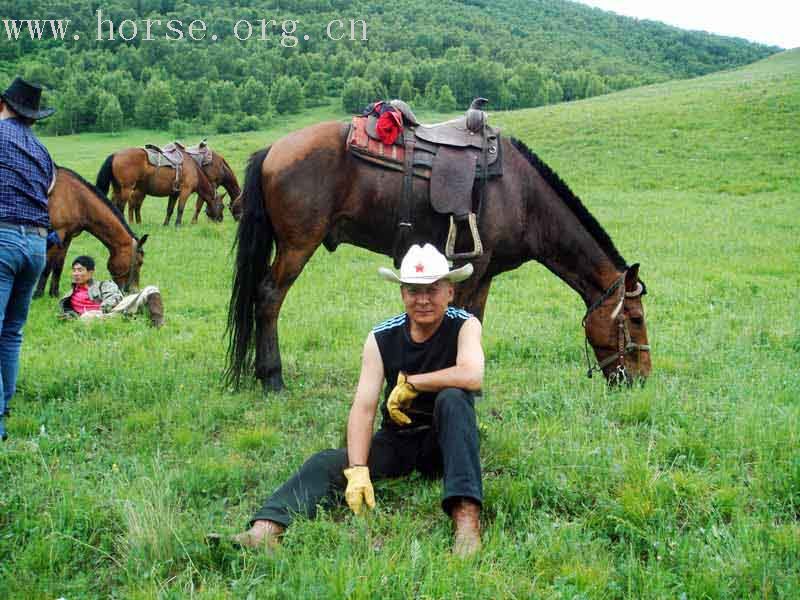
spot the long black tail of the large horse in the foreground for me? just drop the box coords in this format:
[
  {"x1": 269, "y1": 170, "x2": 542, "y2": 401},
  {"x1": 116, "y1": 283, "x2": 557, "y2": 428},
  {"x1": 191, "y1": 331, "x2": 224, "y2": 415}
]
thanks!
[{"x1": 225, "y1": 147, "x2": 274, "y2": 388}]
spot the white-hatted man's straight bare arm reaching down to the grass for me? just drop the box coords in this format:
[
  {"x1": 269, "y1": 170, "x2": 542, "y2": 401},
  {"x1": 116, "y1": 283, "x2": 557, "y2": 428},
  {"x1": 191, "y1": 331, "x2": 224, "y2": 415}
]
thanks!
[{"x1": 347, "y1": 333, "x2": 384, "y2": 466}]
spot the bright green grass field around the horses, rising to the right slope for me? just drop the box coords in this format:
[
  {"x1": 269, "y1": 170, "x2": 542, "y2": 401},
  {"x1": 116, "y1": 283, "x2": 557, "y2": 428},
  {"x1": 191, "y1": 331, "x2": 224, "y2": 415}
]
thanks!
[{"x1": 0, "y1": 51, "x2": 800, "y2": 599}]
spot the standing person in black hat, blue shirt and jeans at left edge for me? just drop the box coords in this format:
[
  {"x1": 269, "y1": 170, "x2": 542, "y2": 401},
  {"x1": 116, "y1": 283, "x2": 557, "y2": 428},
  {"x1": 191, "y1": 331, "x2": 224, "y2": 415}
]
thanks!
[{"x1": 0, "y1": 77, "x2": 56, "y2": 440}]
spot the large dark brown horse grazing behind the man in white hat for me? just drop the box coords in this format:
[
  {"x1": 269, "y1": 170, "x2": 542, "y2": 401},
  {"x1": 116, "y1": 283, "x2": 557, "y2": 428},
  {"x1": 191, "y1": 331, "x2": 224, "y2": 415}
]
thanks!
[{"x1": 226, "y1": 122, "x2": 650, "y2": 392}]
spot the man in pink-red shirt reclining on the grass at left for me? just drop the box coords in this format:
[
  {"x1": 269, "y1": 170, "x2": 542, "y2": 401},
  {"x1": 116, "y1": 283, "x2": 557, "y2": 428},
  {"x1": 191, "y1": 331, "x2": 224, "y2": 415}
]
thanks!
[{"x1": 59, "y1": 256, "x2": 164, "y2": 327}]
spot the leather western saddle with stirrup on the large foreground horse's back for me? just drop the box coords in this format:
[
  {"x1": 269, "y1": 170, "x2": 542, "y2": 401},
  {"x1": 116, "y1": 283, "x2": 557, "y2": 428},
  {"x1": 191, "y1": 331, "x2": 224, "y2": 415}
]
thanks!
[{"x1": 347, "y1": 98, "x2": 502, "y2": 265}]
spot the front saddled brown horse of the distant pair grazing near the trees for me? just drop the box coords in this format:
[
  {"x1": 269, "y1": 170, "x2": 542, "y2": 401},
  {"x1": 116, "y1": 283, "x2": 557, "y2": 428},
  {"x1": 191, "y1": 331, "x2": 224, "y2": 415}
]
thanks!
[{"x1": 97, "y1": 148, "x2": 223, "y2": 227}]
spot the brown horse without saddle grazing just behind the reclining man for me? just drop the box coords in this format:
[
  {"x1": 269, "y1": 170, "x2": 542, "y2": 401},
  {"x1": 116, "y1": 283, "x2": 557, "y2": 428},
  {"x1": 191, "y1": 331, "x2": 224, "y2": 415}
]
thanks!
[{"x1": 34, "y1": 167, "x2": 147, "y2": 298}]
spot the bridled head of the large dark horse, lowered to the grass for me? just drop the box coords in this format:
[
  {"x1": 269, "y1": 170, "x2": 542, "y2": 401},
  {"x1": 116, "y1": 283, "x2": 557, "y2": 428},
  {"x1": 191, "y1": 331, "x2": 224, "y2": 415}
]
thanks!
[{"x1": 583, "y1": 263, "x2": 651, "y2": 384}]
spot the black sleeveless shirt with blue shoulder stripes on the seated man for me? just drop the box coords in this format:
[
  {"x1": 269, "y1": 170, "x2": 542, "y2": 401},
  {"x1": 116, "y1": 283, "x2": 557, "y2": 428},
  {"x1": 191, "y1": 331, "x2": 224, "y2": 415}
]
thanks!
[{"x1": 372, "y1": 306, "x2": 472, "y2": 431}]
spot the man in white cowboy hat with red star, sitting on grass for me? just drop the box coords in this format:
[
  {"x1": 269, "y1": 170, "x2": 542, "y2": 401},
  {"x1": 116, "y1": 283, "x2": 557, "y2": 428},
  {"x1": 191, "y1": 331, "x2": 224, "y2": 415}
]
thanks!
[{"x1": 228, "y1": 244, "x2": 484, "y2": 555}]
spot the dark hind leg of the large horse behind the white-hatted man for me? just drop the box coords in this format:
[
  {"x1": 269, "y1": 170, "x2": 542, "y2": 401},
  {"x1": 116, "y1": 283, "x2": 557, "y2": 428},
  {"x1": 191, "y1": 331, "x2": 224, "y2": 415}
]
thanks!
[{"x1": 256, "y1": 244, "x2": 318, "y2": 393}]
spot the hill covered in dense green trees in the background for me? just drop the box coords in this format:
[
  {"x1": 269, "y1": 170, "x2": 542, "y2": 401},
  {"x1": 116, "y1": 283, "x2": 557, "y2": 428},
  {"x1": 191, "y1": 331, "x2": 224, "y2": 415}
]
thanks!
[{"x1": 0, "y1": 0, "x2": 777, "y2": 134}]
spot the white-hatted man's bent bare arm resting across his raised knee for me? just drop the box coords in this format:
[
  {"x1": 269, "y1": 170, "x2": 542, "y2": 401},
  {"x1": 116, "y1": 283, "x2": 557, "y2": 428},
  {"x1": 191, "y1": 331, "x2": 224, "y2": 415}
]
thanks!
[{"x1": 407, "y1": 317, "x2": 483, "y2": 392}]
